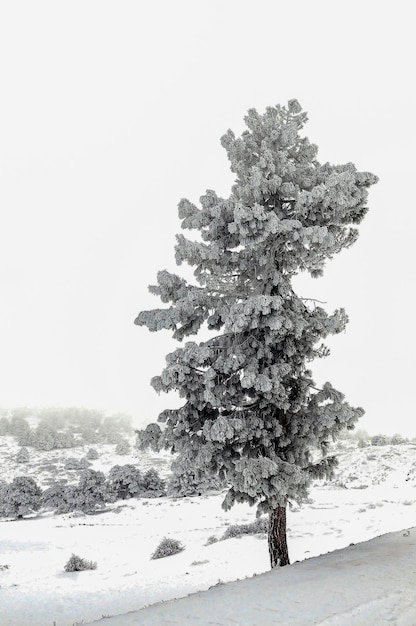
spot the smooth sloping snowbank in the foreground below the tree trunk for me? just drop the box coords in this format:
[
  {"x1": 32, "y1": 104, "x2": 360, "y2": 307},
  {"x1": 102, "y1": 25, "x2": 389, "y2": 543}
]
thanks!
[{"x1": 87, "y1": 528, "x2": 416, "y2": 626}]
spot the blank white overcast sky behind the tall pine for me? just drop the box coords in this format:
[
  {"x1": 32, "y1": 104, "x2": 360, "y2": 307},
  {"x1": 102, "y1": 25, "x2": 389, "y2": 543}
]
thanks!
[{"x1": 0, "y1": 0, "x2": 416, "y2": 435}]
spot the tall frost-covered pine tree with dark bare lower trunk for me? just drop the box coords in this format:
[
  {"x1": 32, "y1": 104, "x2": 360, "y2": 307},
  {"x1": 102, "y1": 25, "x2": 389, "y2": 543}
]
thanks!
[{"x1": 135, "y1": 100, "x2": 377, "y2": 567}]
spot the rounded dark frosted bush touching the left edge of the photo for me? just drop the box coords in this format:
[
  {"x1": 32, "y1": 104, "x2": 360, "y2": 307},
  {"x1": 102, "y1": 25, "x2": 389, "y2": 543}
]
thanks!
[{"x1": 0, "y1": 476, "x2": 42, "y2": 518}]
